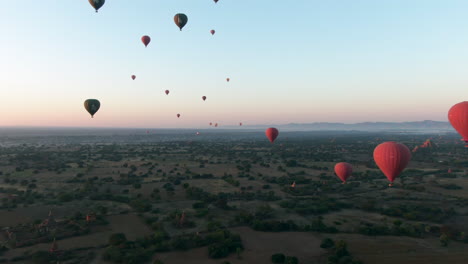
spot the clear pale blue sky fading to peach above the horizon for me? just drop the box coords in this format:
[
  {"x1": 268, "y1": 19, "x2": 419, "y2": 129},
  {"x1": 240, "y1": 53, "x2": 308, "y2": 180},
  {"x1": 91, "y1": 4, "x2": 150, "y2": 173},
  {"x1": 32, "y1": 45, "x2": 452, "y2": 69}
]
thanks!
[{"x1": 0, "y1": 0, "x2": 468, "y2": 127}]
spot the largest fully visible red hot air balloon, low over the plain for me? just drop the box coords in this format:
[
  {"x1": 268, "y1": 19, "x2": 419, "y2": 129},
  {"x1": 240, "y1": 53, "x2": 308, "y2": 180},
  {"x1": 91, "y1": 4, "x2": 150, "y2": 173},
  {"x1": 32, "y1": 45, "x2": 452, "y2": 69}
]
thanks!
[{"x1": 374, "y1": 142, "x2": 411, "y2": 186}]
